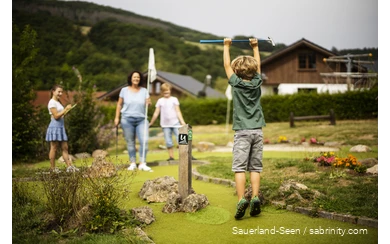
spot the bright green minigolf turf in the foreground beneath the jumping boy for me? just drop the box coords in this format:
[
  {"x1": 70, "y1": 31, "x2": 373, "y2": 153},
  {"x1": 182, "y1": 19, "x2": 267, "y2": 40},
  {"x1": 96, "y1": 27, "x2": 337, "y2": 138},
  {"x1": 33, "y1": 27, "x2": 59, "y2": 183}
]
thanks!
[{"x1": 123, "y1": 165, "x2": 378, "y2": 244}]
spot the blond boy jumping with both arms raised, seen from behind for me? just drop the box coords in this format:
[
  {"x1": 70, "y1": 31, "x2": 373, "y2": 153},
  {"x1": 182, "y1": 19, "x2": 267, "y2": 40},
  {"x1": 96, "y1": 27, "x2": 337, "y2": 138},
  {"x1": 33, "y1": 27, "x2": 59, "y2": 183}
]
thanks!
[{"x1": 223, "y1": 38, "x2": 265, "y2": 219}]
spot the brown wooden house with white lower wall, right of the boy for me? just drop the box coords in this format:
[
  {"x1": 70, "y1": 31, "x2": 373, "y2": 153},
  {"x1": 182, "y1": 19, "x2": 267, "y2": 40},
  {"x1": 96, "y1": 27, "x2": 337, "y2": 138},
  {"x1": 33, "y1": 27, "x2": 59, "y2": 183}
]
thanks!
[{"x1": 261, "y1": 38, "x2": 375, "y2": 95}]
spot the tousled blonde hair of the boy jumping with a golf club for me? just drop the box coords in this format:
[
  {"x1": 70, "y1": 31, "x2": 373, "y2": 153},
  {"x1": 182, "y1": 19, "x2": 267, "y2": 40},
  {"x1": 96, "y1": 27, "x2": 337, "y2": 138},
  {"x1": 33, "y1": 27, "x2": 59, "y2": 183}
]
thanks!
[{"x1": 231, "y1": 55, "x2": 258, "y2": 80}]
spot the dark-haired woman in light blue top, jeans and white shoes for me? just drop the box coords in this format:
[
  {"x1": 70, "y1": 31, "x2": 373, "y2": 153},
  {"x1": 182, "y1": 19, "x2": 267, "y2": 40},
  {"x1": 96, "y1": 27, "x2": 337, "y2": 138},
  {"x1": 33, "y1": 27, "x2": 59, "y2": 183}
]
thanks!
[{"x1": 114, "y1": 71, "x2": 152, "y2": 172}]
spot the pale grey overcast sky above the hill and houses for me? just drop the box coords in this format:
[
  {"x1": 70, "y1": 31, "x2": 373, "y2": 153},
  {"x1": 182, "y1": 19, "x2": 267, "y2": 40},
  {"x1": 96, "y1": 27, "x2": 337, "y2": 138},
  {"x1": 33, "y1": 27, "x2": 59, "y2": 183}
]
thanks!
[{"x1": 65, "y1": 0, "x2": 384, "y2": 50}]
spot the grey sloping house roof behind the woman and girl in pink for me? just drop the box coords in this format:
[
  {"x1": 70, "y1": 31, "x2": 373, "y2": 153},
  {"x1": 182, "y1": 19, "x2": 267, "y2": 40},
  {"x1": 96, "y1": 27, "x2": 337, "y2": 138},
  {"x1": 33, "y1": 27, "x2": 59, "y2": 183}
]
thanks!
[{"x1": 97, "y1": 70, "x2": 225, "y2": 100}]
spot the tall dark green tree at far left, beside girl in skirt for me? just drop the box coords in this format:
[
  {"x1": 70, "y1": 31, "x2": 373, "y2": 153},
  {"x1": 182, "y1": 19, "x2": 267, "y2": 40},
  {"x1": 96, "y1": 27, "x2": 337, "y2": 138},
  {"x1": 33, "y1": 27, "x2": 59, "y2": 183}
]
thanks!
[{"x1": 12, "y1": 25, "x2": 42, "y2": 162}]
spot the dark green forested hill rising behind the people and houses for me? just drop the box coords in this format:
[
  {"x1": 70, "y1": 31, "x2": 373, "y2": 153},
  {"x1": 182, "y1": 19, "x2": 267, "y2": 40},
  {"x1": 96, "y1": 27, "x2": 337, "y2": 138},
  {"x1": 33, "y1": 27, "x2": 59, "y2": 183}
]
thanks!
[{"x1": 12, "y1": 0, "x2": 375, "y2": 91}]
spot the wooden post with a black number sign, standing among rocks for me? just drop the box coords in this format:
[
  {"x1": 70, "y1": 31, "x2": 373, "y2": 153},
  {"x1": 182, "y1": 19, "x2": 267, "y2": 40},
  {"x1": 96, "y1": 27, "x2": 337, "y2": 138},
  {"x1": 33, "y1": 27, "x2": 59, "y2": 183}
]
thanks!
[{"x1": 178, "y1": 124, "x2": 192, "y2": 199}]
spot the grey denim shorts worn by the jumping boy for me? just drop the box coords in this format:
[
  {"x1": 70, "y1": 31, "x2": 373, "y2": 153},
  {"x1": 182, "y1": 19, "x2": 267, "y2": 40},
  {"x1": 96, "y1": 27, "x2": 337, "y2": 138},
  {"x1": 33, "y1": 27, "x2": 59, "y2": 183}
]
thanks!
[{"x1": 232, "y1": 129, "x2": 263, "y2": 172}]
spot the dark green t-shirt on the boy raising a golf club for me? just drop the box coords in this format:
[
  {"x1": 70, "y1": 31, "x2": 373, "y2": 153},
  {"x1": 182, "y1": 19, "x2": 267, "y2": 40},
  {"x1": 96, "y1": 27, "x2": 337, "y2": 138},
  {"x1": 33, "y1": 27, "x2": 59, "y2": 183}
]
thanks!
[{"x1": 229, "y1": 73, "x2": 265, "y2": 130}]
